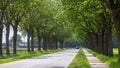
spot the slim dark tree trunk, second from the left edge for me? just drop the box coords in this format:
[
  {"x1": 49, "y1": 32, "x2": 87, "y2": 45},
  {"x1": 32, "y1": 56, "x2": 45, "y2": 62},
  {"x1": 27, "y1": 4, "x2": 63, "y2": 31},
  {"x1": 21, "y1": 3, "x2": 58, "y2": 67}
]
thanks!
[{"x1": 6, "y1": 22, "x2": 10, "y2": 55}]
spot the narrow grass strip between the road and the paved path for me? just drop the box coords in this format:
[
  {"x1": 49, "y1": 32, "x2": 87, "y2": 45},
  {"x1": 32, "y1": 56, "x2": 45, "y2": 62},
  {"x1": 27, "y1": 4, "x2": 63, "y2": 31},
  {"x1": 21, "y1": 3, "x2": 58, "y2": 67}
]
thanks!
[{"x1": 68, "y1": 49, "x2": 90, "y2": 68}]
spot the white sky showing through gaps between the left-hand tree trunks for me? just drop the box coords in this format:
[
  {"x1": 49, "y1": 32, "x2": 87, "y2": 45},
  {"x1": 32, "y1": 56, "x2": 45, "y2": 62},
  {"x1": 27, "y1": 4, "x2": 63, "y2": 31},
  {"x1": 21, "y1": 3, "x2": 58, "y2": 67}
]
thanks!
[{"x1": 2, "y1": 27, "x2": 27, "y2": 43}]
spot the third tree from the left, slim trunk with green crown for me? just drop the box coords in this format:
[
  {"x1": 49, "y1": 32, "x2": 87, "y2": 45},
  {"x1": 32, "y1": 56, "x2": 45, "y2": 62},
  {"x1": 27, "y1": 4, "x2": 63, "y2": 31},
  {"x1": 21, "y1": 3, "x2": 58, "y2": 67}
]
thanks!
[{"x1": 10, "y1": 0, "x2": 27, "y2": 54}]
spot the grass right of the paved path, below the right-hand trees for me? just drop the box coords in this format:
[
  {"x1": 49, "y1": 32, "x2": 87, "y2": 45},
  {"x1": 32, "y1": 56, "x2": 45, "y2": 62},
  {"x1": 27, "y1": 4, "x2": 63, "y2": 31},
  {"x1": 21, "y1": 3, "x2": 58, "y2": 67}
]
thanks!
[{"x1": 88, "y1": 49, "x2": 120, "y2": 68}]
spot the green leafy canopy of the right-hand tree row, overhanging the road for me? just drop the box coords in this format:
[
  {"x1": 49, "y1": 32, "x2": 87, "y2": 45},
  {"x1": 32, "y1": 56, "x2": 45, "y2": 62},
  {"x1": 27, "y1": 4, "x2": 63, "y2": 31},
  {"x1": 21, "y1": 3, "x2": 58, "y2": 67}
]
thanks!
[{"x1": 62, "y1": 0, "x2": 105, "y2": 42}]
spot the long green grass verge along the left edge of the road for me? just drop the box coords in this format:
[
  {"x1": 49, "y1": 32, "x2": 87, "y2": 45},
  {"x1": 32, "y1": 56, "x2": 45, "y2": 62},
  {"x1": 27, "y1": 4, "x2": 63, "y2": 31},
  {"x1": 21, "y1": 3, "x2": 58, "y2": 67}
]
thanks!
[{"x1": 0, "y1": 49, "x2": 65, "y2": 64}]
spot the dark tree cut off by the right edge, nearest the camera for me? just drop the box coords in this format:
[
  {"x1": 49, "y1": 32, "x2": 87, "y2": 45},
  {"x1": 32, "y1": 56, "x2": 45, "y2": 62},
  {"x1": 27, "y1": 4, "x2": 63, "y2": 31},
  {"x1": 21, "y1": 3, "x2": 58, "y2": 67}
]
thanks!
[{"x1": 100, "y1": 0, "x2": 120, "y2": 62}]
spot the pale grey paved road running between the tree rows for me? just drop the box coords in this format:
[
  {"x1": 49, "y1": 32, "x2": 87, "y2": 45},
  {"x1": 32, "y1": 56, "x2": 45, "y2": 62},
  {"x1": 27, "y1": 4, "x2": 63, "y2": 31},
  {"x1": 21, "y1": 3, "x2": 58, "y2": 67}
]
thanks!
[{"x1": 0, "y1": 49, "x2": 78, "y2": 68}]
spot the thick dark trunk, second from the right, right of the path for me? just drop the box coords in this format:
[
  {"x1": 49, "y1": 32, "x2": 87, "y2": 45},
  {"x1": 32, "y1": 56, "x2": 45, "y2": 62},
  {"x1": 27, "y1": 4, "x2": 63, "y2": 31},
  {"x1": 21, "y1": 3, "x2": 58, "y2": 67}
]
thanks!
[{"x1": 100, "y1": 12, "x2": 113, "y2": 57}]
